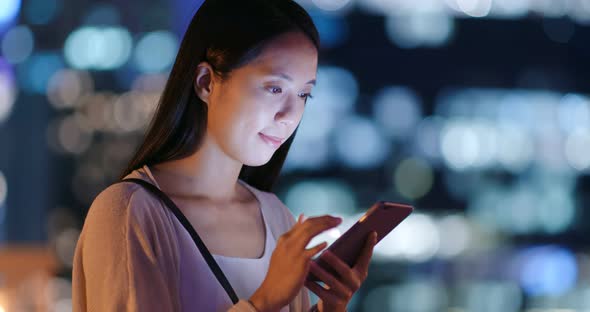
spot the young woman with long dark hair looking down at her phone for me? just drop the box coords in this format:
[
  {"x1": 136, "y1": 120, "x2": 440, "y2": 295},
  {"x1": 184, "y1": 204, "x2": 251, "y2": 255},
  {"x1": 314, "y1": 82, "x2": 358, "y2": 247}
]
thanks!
[{"x1": 73, "y1": 0, "x2": 375, "y2": 312}]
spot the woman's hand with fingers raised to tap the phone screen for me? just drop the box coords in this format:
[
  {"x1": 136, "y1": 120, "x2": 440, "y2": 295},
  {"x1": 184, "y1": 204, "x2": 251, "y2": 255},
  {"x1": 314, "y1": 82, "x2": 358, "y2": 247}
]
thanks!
[{"x1": 250, "y1": 215, "x2": 342, "y2": 312}]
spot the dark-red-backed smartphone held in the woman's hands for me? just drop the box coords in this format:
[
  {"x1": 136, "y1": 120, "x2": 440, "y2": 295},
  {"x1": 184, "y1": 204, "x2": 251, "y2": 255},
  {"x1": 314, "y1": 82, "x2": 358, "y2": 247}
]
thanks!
[{"x1": 307, "y1": 201, "x2": 414, "y2": 281}]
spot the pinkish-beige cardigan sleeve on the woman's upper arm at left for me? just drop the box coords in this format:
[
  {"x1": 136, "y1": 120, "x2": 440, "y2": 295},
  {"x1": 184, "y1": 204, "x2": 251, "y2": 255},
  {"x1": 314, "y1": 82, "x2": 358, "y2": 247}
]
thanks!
[{"x1": 72, "y1": 185, "x2": 180, "y2": 312}]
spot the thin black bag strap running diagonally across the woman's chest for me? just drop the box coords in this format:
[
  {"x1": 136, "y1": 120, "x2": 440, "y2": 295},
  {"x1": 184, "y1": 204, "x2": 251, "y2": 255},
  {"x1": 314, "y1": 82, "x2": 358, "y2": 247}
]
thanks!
[{"x1": 121, "y1": 178, "x2": 239, "y2": 304}]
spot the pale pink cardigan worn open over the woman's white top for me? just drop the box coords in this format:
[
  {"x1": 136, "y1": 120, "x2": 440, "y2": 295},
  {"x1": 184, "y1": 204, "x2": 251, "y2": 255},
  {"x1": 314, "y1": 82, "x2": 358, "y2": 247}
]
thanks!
[{"x1": 72, "y1": 166, "x2": 310, "y2": 312}]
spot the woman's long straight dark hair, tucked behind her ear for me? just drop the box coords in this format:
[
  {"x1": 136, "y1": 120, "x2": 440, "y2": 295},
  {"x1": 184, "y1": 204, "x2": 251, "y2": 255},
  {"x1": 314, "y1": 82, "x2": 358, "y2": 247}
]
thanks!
[{"x1": 120, "y1": 0, "x2": 319, "y2": 191}]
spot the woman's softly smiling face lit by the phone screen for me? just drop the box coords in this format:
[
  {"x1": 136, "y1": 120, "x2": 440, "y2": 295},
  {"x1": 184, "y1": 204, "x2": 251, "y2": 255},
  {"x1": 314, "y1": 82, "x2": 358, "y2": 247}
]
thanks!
[{"x1": 207, "y1": 32, "x2": 318, "y2": 166}]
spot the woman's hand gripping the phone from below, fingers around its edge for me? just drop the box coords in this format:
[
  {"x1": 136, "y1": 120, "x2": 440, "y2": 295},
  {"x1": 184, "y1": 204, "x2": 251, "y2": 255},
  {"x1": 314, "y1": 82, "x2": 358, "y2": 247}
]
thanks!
[{"x1": 305, "y1": 232, "x2": 377, "y2": 312}]
